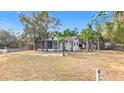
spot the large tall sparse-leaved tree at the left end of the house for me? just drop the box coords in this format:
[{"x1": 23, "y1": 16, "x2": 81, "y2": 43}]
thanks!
[{"x1": 20, "y1": 11, "x2": 60, "y2": 50}]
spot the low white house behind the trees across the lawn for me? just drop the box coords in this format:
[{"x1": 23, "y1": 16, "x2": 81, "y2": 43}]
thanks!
[{"x1": 40, "y1": 36, "x2": 80, "y2": 51}]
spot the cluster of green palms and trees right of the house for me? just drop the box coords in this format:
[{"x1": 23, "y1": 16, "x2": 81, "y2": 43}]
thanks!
[{"x1": 81, "y1": 11, "x2": 124, "y2": 52}]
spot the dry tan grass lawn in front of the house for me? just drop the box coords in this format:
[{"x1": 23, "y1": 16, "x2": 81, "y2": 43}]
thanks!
[{"x1": 0, "y1": 51, "x2": 124, "y2": 80}]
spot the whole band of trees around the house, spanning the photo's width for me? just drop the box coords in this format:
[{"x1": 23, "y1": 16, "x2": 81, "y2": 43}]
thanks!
[{"x1": 0, "y1": 11, "x2": 124, "y2": 52}]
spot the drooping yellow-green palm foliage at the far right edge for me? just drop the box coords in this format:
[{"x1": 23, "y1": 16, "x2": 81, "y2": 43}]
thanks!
[{"x1": 103, "y1": 11, "x2": 124, "y2": 44}]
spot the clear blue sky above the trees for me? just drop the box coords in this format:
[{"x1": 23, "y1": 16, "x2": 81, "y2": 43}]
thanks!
[{"x1": 0, "y1": 11, "x2": 96, "y2": 33}]
